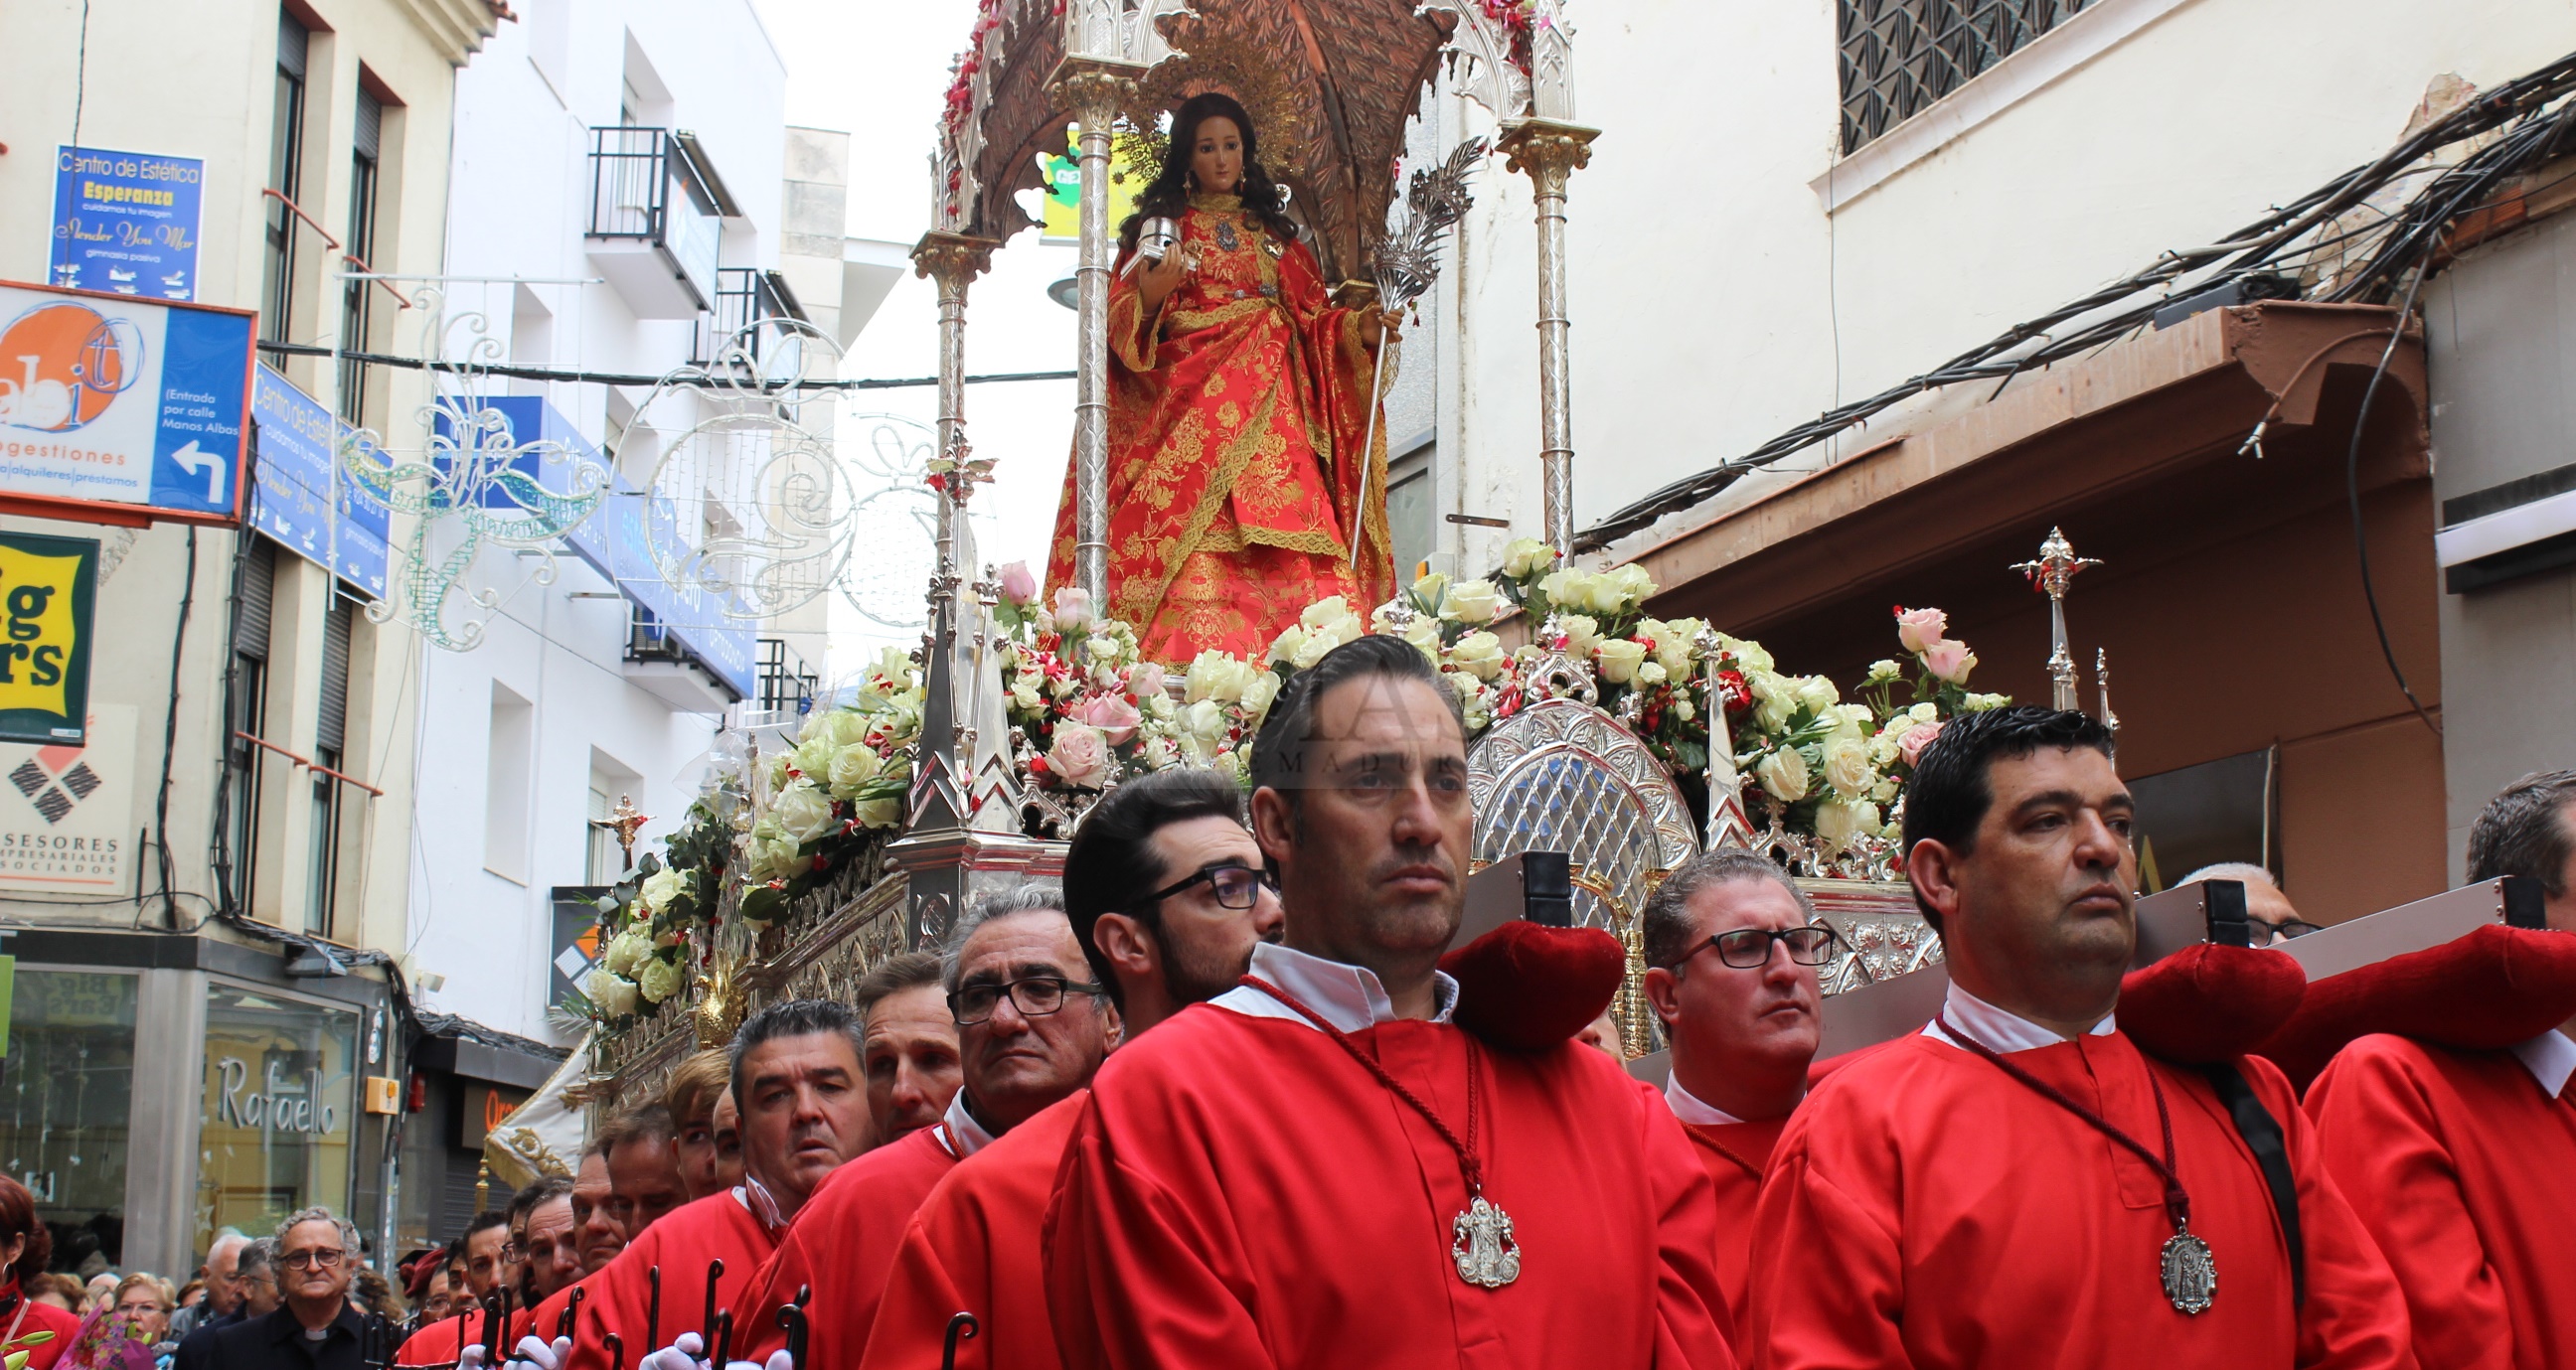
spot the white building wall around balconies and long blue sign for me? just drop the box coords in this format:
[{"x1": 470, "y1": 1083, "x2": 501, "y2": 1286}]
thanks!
[{"x1": 409, "y1": 0, "x2": 786, "y2": 1038}]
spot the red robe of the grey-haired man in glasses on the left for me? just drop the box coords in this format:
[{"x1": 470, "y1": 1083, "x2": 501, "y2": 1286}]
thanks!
[{"x1": 734, "y1": 1123, "x2": 958, "y2": 1370}]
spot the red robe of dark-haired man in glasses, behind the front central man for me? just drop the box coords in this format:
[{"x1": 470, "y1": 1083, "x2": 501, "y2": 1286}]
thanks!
[{"x1": 858, "y1": 1089, "x2": 1089, "y2": 1370}]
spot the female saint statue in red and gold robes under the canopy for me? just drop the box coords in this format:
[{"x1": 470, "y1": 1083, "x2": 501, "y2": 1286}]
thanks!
[{"x1": 1046, "y1": 92, "x2": 1398, "y2": 662}]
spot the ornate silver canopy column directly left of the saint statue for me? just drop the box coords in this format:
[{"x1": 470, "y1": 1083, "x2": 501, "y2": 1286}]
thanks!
[{"x1": 1048, "y1": 57, "x2": 1141, "y2": 610}]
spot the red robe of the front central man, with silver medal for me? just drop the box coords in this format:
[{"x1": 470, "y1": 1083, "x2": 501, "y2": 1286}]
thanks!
[{"x1": 1046, "y1": 998, "x2": 1736, "y2": 1370}]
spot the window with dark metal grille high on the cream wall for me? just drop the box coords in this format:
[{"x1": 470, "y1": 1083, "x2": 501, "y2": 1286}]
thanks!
[{"x1": 1837, "y1": 0, "x2": 2097, "y2": 155}]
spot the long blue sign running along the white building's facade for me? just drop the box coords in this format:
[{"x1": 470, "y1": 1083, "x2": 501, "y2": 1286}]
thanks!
[{"x1": 438, "y1": 394, "x2": 760, "y2": 697}]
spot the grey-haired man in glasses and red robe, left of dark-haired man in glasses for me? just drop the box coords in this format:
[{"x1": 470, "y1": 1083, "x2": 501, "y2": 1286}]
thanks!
[{"x1": 752, "y1": 883, "x2": 1118, "y2": 1367}]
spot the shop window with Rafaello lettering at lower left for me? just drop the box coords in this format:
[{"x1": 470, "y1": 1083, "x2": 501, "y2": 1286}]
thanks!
[{"x1": 196, "y1": 984, "x2": 358, "y2": 1252}]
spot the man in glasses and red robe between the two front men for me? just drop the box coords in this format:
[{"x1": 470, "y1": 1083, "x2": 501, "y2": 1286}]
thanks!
[{"x1": 1639, "y1": 849, "x2": 1835, "y2": 1326}]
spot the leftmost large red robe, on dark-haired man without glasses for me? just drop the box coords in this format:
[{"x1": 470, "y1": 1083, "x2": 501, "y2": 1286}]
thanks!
[{"x1": 549, "y1": 1190, "x2": 778, "y2": 1370}]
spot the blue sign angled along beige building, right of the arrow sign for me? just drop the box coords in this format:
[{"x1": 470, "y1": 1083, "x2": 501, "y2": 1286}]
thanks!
[{"x1": 249, "y1": 363, "x2": 395, "y2": 600}]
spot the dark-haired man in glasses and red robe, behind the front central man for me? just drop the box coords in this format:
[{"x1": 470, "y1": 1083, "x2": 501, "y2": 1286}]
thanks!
[{"x1": 861, "y1": 770, "x2": 1280, "y2": 1370}]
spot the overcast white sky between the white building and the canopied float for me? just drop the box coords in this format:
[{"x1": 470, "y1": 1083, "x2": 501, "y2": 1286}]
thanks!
[{"x1": 754, "y1": 0, "x2": 1074, "y2": 673}]
